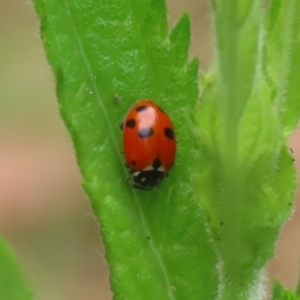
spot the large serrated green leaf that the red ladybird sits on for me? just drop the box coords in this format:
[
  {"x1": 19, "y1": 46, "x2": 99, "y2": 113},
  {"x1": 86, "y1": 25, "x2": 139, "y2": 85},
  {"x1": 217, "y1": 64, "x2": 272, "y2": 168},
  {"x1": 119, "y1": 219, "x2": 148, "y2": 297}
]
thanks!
[{"x1": 34, "y1": 0, "x2": 217, "y2": 300}]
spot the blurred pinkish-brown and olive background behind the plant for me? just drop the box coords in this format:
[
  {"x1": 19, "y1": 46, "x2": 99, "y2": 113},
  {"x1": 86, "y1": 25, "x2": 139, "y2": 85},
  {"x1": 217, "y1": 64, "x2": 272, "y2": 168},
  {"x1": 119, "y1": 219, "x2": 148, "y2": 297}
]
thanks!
[{"x1": 0, "y1": 0, "x2": 300, "y2": 300}]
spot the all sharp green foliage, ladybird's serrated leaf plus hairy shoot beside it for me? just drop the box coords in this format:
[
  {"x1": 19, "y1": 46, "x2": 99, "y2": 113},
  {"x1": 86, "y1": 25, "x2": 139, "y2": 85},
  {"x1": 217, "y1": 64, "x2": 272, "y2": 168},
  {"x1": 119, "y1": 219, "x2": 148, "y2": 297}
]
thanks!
[{"x1": 33, "y1": 0, "x2": 300, "y2": 300}]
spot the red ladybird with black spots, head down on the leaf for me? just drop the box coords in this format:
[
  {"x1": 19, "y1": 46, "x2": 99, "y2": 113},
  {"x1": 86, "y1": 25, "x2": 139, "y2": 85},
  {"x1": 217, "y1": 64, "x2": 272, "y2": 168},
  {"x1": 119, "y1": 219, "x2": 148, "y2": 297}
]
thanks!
[{"x1": 121, "y1": 100, "x2": 176, "y2": 190}]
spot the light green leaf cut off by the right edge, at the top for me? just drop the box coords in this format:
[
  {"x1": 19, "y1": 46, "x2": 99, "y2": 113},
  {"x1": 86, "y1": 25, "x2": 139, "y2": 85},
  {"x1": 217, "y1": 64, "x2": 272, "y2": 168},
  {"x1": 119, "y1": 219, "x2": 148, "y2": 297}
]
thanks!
[{"x1": 266, "y1": 0, "x2": 300, "y2": 135}]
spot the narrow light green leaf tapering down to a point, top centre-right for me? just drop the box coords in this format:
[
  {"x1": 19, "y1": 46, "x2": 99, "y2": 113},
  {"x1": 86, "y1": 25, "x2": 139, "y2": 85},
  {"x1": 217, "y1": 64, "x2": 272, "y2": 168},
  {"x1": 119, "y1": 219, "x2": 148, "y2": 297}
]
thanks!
[{"x1": 215, "y1": 0, "x2": 262, "y2": 125}]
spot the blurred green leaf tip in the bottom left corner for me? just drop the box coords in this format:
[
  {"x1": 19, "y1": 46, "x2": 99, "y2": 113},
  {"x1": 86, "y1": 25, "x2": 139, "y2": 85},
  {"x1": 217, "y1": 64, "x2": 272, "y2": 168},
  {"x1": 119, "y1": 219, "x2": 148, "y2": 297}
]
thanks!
[{"x1": 0, "y1": 238, "x2": 33, "y2": 300}]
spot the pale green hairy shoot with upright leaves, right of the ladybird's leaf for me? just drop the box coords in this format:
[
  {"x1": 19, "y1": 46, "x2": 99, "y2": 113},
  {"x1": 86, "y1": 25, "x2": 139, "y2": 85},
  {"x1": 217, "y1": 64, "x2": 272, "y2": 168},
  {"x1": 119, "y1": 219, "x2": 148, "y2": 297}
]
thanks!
[{"x1": 195, "y1": 0, "x2": 300, "y2": 300}]
